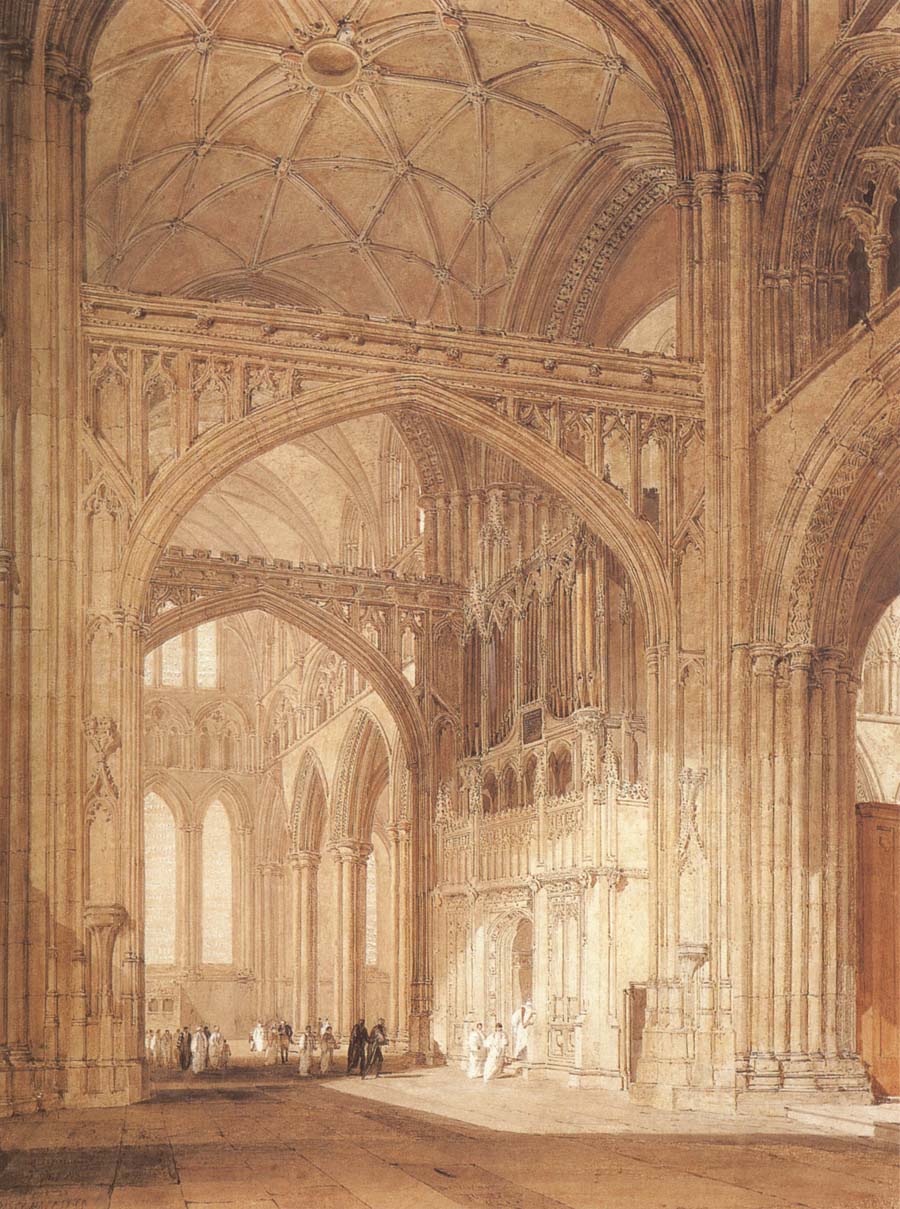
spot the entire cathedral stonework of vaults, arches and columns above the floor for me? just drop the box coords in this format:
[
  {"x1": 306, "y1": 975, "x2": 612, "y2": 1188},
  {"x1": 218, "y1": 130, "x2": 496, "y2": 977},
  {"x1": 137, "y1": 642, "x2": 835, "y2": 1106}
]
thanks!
[{"x1": 0, "y1": 0, "x2": 900, "y2": 1150}]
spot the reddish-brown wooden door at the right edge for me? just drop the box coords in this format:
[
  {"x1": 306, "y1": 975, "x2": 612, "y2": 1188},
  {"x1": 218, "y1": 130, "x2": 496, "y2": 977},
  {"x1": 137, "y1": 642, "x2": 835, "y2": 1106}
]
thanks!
[{"x1": 856, "y1": 802, "x2": 900, "y2": 1097}]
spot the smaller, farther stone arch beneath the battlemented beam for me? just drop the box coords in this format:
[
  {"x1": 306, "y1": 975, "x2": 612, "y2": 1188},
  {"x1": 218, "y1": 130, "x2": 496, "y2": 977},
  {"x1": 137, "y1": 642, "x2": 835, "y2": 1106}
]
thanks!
[{"x1": 148, "y1": 589, "x2": 428, "y2": 773}]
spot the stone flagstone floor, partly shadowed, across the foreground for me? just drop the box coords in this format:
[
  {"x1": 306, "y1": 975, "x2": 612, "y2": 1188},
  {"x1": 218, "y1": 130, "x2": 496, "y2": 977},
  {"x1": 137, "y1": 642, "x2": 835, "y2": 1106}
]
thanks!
[{"x1": 0, "y1": 1060, "x2": 900, "y2": 1209}]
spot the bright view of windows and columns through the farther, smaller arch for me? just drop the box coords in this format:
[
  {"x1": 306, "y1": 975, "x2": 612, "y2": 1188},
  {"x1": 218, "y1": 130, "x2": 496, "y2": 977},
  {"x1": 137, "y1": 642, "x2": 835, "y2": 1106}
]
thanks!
[{"x1": 143, "y1": 599, "x2": 410, "y2": 1069}]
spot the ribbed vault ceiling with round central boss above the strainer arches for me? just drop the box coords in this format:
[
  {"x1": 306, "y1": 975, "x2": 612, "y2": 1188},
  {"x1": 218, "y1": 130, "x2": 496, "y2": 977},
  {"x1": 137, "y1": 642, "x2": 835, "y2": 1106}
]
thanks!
[{"x1": 87, "y1": 0, "x2": 665, "y2": 330}]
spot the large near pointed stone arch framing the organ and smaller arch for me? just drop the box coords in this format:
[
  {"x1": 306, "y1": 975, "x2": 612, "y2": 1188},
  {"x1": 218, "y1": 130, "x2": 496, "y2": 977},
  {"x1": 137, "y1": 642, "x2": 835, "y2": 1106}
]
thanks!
[{"x1": 119, "y1": 374, "x2": 675, "y2": 646}]
